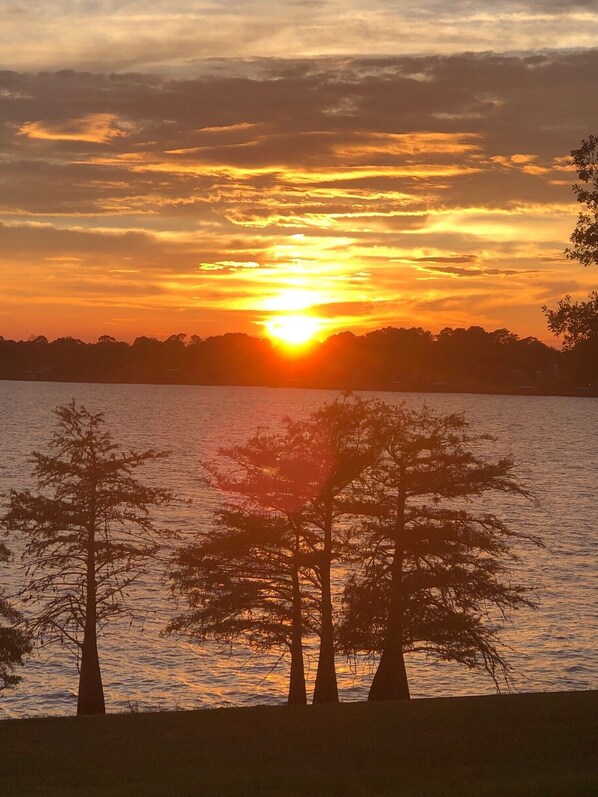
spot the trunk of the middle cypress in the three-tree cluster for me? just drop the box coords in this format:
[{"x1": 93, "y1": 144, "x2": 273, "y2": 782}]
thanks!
[{"x1": 313, "y1": 499, "x2": 338, "y2": 703}]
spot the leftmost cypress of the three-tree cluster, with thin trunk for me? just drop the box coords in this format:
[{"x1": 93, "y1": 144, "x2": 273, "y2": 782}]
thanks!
[{"x1": 167, "y1": 430, "x2": 313, "y2": 704}]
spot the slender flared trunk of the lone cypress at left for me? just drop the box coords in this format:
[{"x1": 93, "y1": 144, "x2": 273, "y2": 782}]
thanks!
[{"x1": 77, "y1": 512, "x2": 106, "y2": 714}]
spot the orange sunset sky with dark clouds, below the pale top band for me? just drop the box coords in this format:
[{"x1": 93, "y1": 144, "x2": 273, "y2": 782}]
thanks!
[{"x1": 0, "y1": 51, "x2": 598, "y2": 345}]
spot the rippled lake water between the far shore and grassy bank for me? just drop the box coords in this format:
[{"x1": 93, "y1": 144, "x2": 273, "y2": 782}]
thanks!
[{"x1": 0, "y1": 382, "x2": 598, "y2": 717}]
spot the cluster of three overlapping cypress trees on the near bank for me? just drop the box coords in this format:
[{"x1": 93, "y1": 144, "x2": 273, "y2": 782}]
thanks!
[{"x1": 169, "y1": 395, "x2": 540, "y2": 702}]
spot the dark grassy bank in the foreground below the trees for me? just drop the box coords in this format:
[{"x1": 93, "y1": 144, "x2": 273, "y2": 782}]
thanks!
[{"x1": 0, "y1": 692, "x2": 598, "y2": 797}]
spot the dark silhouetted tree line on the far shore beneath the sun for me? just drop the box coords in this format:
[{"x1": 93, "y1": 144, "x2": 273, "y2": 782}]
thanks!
[{"x1": 0, "y1": 326, "x2": 596, "y2": 393}]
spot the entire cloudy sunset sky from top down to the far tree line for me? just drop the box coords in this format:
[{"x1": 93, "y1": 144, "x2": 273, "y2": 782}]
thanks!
[{"x1": 0, "y1": 0, "x2": 598, "y2": 342}]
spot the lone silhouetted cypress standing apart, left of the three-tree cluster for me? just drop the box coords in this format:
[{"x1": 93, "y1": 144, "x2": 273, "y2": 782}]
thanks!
[{"x1": 3, "y1": 401, "x2": 171, "y2": 714}]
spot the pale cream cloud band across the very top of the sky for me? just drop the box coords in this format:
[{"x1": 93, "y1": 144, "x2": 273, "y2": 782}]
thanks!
[{"x1": 0, "y1": 0, "x2": 598, "y2": 75}]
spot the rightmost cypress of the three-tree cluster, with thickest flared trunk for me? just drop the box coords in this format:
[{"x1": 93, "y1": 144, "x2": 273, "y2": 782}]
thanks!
[{"x1": 339, "y1": 404, "x2": 537, "y2": 700}]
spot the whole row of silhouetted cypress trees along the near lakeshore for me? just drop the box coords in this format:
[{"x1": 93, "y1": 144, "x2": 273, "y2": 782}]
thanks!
[{"x1": 0, "y1": 394, "x2": 541, "y2": 714}]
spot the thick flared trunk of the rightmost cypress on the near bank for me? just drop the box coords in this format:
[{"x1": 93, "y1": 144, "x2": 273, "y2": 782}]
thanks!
[{"x1": 368, "y1": 478, "x2": 410, "y2": 700}]
